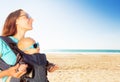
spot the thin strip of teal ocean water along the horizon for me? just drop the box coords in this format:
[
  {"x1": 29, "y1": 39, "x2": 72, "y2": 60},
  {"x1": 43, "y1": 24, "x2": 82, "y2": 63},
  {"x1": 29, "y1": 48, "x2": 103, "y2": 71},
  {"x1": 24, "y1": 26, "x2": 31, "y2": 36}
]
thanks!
[{"x1": 44, "y1": 49, "x2": 120, "y2": 54}]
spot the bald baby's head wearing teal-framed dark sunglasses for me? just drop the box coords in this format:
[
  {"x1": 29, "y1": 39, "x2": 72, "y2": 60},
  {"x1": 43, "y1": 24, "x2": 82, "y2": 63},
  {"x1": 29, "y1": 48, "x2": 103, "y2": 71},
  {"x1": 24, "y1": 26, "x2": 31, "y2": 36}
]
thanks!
[{"x1": 17, "y1": 37, "x2": 40, "y2": 54}]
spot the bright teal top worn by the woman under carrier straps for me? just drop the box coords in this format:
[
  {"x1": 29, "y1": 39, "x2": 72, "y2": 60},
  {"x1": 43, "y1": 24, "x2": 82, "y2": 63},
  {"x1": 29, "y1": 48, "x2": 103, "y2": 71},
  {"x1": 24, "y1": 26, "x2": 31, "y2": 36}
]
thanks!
[{"x1": 0, "y1": 36, "x2": 18, "y2": 82}]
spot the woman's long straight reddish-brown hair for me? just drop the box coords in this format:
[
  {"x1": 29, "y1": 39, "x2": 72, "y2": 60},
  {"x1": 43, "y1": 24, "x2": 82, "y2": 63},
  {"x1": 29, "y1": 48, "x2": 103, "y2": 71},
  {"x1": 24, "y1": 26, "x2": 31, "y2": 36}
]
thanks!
[{"x1": 2, "y1": 9, "x2": 23, "y2": 36}]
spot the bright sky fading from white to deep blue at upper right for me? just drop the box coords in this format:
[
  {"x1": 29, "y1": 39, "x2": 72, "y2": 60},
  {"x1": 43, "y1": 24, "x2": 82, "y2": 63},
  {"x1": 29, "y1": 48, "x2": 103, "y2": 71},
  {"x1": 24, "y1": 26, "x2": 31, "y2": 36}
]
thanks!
[{"x1": 0, "y1": 0, "x2": 120, "y2": 50}]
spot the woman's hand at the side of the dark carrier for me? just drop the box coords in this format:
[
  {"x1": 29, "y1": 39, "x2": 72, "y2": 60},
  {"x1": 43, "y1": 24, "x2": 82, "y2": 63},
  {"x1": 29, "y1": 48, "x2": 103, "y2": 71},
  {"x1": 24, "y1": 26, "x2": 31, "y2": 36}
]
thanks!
[{"x1": 7, "y1": 64, "x2": 27, "y2": 78}]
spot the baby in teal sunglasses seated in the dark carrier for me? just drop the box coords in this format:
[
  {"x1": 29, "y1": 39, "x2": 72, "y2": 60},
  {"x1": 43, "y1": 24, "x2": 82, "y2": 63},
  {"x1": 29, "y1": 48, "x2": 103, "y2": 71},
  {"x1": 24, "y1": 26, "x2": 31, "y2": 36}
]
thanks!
[{"x1": 6, "y1": 37, "x2": 59, "y2": 82}]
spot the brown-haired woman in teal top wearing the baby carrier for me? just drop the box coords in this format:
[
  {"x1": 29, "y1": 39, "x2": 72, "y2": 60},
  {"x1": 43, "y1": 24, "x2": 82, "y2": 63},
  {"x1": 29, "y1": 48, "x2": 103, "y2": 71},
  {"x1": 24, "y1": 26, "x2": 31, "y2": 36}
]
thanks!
[{"x1": 0, "y1": 9, "x2": 33, "y2": 82}]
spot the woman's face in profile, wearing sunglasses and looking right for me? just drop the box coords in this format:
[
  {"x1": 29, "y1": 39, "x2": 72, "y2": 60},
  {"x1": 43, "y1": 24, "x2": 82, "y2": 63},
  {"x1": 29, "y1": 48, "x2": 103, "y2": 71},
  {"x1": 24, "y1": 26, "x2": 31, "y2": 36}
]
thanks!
[{"x1": 16, "y1": 11, "x2": 33, "y2": 31}]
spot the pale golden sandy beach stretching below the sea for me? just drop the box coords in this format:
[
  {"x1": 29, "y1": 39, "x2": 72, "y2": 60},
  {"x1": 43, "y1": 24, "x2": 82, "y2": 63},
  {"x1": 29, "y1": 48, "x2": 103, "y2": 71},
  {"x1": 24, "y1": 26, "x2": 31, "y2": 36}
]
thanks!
[{"x1": 47, "y1": 54, "x2": 120, "y2": 82}]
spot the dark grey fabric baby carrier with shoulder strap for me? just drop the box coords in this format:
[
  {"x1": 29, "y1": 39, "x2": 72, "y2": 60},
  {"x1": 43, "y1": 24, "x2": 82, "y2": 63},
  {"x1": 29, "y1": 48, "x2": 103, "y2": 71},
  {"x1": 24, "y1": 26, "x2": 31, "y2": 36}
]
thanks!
[{"x1": 0, "y1": 36, "x2": 49, "y2": 82}]
